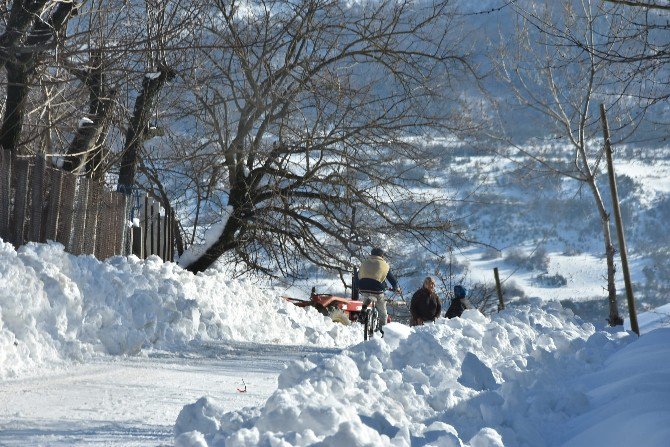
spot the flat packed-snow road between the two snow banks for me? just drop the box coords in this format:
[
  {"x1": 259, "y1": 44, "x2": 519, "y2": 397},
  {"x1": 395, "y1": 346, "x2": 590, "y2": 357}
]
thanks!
[{"x1": 0, "y1": 344, "x2": 337, "y2": 446}]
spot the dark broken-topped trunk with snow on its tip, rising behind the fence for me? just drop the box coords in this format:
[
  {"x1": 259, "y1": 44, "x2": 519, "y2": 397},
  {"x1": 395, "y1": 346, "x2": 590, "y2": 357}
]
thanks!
[{"x1": 117, "y1": 68, "x2": 175, "y2": 194}]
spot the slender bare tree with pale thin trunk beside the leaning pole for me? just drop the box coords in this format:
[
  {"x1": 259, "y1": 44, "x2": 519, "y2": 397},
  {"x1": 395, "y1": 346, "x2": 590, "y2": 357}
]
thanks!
[{"x1": 499, "y1": 0, "x2": 634, "y2": 326}]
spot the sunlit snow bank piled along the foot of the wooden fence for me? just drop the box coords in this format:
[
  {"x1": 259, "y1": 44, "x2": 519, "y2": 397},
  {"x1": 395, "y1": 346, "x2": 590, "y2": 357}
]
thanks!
[{"x1": 0, "y1": 241, "x2": 362, "y2": 378}]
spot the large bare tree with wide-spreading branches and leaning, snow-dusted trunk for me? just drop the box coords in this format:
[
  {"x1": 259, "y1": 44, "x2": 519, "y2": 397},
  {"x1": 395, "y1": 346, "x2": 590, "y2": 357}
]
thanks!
[{"x1": 155, "y1": 0, "x2": 474, "y2": 274}]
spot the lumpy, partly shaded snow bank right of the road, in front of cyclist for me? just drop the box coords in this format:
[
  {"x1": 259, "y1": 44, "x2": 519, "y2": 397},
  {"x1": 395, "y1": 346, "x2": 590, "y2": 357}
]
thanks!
[{"x1": 175, "y1": 301, "x2": 670, "y2": 447}]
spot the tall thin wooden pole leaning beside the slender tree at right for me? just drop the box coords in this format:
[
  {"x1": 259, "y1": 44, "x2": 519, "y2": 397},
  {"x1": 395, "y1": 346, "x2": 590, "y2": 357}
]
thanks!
[{"x1": 600, "y1": 104, "x2": 640, "y2": 335}]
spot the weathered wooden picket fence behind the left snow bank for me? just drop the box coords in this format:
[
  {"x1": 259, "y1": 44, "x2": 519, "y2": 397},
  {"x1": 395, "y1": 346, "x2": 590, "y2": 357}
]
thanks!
[{"x1": 0, "y1": 150, "x2": 175, "y2": 260}]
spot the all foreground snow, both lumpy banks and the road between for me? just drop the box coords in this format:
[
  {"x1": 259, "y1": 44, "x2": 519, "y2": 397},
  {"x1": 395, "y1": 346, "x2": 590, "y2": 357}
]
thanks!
[{"x1": 0, "y1": 244, "x2": 670, "y2": 447}]
